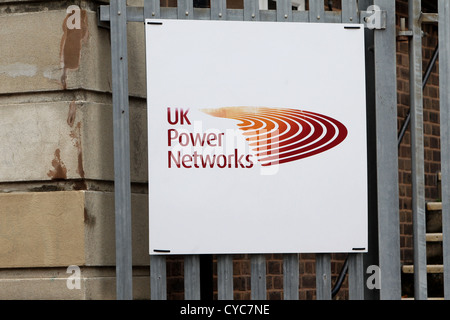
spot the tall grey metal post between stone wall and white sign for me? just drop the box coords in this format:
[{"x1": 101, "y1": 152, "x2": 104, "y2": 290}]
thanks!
[{"x1": 110, "y1": 0, "x2": 133, "y2": 300}]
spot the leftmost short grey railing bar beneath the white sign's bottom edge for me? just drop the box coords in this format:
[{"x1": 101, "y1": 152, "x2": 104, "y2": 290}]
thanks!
[{"x1": 150, "y1": 255, "x2": 167, "y2": 300}]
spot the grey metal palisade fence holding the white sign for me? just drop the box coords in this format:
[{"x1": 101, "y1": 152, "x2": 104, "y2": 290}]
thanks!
[{"x1": 99, "y1": 0, "x2": 450, "y2": 300}]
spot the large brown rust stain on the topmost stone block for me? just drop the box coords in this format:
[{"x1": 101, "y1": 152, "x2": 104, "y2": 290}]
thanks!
[{"x1": 60, "y1": 9, "x2": 89, "y2": 89}]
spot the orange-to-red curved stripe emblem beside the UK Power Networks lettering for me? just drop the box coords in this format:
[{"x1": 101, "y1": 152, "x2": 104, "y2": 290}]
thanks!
[{"x1": 202, "y1": 107, "x2": 348, "y2": 166}]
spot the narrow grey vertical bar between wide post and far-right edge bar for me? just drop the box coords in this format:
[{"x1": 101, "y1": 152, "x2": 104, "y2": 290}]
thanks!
[{"x1": 408, "y1": 0, "x2": 427, "y2": 300}]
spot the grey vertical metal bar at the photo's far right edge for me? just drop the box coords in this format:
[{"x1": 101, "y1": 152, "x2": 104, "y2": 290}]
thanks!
[{"x1": 438, "y1": 0, "x2": 450, "y2": 300}]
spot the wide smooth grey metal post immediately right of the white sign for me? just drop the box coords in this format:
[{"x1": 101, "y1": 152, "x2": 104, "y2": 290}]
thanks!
[{"x1": 374, "y1": 0, "x2": 401, "y2": 300}]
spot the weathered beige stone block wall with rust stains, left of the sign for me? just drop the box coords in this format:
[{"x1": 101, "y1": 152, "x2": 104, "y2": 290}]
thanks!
[{"x1": 0, "y1": 0, "x2": 150, "y2": 299}]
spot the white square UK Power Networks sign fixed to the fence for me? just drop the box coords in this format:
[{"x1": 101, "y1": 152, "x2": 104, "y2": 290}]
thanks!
[{"x1": 146, "y1": 20, "x2": 367, "y2": 254}]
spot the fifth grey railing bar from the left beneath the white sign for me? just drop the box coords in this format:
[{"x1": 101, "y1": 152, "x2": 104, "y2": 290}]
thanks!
[{"x1": 283, "y1": 253, "x2": 300, "y2": 300}]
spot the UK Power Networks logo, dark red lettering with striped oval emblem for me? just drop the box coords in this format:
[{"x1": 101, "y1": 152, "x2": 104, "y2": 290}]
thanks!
[{"x1": 167, "y1": 107, "x2": 348, "y2": 170}]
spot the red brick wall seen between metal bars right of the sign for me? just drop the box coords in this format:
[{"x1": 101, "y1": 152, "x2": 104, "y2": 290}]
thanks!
[{"x1": 397, "y1": 0, "x2": 440, "y2": 264}]
